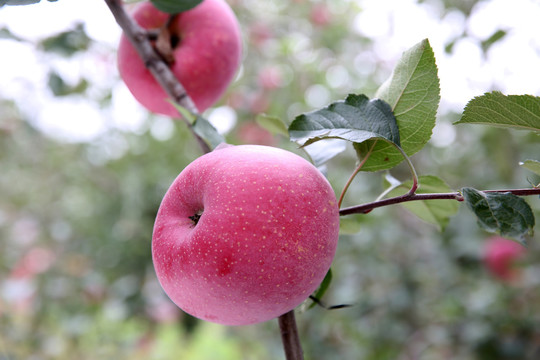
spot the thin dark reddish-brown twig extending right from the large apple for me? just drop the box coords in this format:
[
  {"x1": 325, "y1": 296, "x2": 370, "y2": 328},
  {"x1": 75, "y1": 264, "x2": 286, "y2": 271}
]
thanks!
[{"x1": 339, "y1": 188, "x2": 540, "y2": 216}]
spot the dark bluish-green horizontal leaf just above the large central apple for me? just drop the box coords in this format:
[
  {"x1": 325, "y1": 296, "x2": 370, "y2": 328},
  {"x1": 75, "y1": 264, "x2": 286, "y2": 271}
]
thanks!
[{"x1": 289, "y1": 94, "x2": 400, "y2": 146}]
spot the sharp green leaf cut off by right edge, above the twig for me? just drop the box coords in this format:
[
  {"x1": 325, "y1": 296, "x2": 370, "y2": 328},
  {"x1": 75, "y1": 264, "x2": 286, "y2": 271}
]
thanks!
[{"x1": 454, "y1": 91, "x2": 540, "y2": 131}]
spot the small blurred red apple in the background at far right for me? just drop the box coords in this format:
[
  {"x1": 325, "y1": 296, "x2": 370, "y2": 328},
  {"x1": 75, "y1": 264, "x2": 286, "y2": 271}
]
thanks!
[{"x1": 484, "y1": 236, "x2": 525, "y2": 282}]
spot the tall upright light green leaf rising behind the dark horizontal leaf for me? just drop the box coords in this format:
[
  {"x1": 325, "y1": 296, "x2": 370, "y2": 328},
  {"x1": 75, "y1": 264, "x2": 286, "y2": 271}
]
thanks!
[{"x1": 355, "y1": 40, "x2": 440, "y2": 171}]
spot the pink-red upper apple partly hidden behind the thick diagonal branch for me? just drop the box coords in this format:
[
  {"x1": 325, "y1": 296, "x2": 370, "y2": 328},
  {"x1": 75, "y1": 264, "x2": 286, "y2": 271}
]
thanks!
[{"x1": 118, "y1": 0, "x2": 242, "y2": 117}]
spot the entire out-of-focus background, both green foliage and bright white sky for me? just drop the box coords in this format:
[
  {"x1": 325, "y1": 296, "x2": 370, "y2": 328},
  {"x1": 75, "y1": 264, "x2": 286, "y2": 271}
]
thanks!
[{"x1": 0, "y1": 0, "x2": 540, "y2": 360}]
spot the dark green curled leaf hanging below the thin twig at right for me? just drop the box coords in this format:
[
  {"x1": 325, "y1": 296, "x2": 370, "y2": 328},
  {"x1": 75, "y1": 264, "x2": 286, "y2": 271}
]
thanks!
[{"x1": 462, "y1": 188, "x2": 535, "y2": 240}]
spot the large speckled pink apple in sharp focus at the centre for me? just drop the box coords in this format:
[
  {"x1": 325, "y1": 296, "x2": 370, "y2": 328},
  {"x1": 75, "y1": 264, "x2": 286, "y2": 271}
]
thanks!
[{"x1": 152, "y1": 145, "x2": 339, "y2": 325}]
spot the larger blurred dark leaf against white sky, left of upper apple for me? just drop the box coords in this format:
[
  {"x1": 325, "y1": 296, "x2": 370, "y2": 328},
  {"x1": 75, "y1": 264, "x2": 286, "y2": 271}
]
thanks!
[{"x1": 40, "y1": 24, "x2": 91, "y2": 56}]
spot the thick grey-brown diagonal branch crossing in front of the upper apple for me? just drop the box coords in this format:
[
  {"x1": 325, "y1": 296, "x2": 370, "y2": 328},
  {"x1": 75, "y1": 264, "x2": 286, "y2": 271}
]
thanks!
[{"x1": 105, "y1": 0, "x2": 212, "y2": 153}]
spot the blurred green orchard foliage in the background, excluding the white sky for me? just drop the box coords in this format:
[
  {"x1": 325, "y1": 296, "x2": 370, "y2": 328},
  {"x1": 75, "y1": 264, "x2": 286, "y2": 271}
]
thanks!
[{"x1": 0, "y1": 0, "x2": 540, "y2": 360}]
